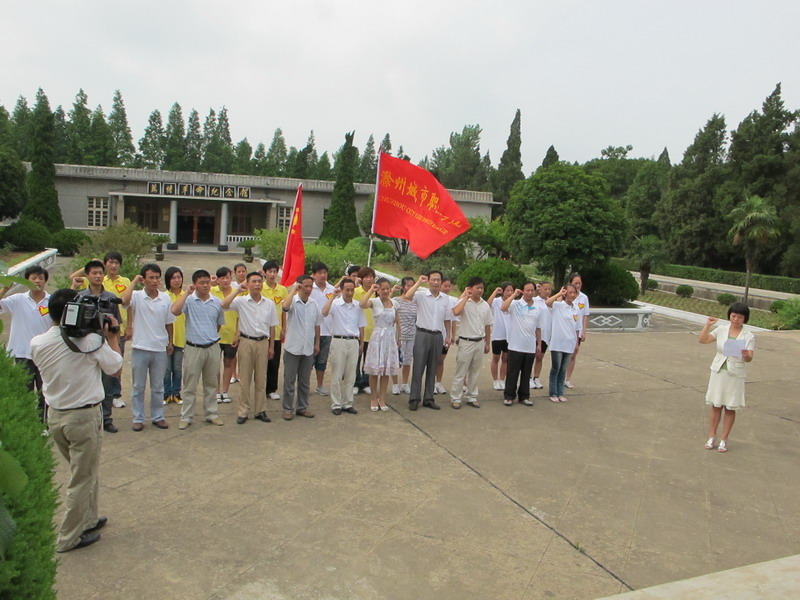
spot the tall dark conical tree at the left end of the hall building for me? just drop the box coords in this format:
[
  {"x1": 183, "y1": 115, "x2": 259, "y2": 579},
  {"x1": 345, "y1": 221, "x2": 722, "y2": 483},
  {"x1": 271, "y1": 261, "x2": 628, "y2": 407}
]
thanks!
[{"x1": 22, "y1": 88, "x2": 64, "y2": 233}]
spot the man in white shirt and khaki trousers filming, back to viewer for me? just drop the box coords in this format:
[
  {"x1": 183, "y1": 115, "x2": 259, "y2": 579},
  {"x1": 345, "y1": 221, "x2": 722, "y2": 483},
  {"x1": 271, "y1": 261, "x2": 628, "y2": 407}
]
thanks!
[{"x1": 31, "y1": 289, "x2": 122, "y2": 552}]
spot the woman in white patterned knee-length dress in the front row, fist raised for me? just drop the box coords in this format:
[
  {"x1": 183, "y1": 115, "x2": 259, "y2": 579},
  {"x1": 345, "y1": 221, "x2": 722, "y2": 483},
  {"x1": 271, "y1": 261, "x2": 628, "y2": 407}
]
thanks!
[{"x1": 359, "y1": 277, "x2": 400, "y2": 411}]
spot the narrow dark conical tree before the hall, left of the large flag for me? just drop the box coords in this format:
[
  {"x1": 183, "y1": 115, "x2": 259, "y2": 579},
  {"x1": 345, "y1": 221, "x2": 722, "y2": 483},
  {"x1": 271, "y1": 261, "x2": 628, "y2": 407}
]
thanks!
[{"x1": 319, "y1": 131, "x2": 361, "y2": 245}]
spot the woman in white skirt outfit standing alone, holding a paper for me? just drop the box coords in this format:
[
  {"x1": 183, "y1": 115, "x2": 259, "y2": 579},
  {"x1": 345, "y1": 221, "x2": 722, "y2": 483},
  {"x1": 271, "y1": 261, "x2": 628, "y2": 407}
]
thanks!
[{"x1": 700, "y1": 302, "x2": 756, "y2": 452}]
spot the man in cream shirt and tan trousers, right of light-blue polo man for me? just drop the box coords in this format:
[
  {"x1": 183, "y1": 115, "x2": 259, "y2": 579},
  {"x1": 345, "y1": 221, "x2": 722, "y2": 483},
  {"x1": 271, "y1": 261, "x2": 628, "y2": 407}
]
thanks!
[{"x1": 222, "y1": 271, "x2": 280, "y2": 425}]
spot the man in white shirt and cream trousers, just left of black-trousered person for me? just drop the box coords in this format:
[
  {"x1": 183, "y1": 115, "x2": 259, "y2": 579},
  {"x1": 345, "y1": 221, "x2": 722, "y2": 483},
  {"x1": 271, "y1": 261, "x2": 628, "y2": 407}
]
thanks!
[{"x1": 450, "y1": 277, "x2": 494, "y2": 408}]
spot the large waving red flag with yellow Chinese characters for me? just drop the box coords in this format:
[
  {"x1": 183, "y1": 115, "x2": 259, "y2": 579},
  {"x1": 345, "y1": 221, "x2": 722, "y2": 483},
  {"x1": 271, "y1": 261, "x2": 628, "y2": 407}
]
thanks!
[{"x1": 372, "y1": 153, "x2": 469, "y2": 258}]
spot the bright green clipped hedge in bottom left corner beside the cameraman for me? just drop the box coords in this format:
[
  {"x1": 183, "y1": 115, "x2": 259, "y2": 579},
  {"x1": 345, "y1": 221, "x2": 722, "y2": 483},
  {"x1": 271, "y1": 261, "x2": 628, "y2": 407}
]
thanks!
[{"x1": 0, "y1": 352, "x2": 57, "y2": 598}]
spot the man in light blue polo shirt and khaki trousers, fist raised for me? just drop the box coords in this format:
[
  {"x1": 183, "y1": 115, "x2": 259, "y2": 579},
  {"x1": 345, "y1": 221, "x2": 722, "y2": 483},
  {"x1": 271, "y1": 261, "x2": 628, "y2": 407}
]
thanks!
[{"x1": 170, "y1": 269, "x2": 225, "y2": 429}]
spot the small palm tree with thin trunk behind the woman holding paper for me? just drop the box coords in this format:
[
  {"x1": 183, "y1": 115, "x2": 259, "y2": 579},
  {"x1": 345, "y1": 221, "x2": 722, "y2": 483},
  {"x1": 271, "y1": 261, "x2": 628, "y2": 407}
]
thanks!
[{"x1": 728, "y1": 196, "x2": 780, "y2": 304}]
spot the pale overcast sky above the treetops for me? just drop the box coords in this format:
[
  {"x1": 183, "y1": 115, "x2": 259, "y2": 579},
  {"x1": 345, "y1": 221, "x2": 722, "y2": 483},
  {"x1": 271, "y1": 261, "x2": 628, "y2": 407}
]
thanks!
[{"x1": 0, "y1": 0, "x2": 800, "y2": 175}]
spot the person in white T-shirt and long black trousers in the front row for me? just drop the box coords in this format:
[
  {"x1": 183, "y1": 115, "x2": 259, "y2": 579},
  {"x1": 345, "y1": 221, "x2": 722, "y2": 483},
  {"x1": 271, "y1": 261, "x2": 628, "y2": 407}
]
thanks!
[{"x1": 501, "y1": 281, "x2": 542, "y2": 406}]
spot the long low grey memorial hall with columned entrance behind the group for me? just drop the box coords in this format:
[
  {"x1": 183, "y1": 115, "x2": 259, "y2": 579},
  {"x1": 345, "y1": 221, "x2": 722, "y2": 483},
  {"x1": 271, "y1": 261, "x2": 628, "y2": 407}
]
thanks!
[{"x1": 51, "y1": 164, "x2": 494, "y2": 251}]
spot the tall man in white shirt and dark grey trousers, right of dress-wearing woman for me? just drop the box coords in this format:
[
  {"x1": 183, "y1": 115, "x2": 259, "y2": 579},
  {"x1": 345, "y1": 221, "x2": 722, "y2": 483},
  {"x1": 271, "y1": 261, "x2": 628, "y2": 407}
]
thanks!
[{"x1": 403, "y1": 271, "x2": 452, "y2": 410}]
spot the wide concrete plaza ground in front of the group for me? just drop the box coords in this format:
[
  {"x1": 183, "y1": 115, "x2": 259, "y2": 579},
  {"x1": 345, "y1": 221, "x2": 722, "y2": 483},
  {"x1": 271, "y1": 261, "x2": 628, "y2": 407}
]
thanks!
[{"x1": 45, "y1": 252, "x2": 800, "y2": 600}]
